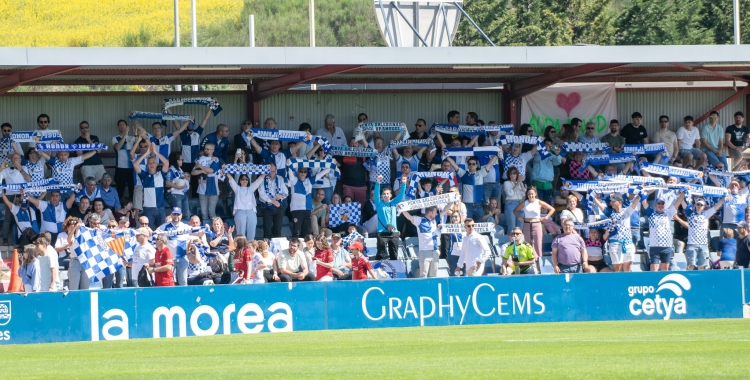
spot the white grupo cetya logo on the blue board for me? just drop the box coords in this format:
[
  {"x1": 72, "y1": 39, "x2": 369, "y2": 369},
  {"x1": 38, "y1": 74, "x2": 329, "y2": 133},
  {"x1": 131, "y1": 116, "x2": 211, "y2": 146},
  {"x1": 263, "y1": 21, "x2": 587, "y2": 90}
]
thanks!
[{"x1": 628, "y1": 273, "x2": 691, "y2": 320}]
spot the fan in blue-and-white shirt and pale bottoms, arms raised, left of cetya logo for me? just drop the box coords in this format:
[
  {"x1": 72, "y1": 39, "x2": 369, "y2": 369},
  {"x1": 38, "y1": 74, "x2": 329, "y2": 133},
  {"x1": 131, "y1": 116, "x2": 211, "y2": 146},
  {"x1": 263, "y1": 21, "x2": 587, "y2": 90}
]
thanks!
[{"x1": 593, "y1": 191, "x2": 644, "y2": 272}]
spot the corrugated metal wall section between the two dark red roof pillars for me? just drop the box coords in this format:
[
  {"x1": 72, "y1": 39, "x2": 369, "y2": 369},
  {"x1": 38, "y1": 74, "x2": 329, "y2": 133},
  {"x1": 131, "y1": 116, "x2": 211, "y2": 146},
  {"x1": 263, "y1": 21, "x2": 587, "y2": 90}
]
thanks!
[{"x1": 261, "y1": 92, "x2": 502, "y2": 136}]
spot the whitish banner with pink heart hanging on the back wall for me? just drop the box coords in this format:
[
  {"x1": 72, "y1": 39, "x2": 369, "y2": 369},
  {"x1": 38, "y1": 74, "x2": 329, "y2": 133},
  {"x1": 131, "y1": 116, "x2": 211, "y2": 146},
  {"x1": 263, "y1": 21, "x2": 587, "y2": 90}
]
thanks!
[{"x1": 521, "y1": 83, "x2": 617, "y2": 137}]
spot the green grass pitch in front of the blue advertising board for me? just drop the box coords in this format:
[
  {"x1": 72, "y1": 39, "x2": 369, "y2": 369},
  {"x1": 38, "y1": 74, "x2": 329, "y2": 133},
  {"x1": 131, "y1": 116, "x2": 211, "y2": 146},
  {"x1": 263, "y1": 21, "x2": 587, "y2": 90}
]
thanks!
[{"x1": 0, "y1": 319, "x2": 750, "y2": 380}]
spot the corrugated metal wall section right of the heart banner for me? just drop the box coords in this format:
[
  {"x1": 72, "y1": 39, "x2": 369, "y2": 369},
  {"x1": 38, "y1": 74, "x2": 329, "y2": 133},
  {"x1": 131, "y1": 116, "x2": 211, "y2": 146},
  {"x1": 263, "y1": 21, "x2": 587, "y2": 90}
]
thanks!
[{"x1": 617, "y1": 90, "x2": 748, "y2": 135}]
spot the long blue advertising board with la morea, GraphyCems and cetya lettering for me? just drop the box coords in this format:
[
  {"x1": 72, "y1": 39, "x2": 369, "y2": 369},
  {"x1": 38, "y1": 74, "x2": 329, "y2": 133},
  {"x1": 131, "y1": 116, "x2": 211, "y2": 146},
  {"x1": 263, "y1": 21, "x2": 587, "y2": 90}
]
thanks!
[{"x1": 0, "y1": 270, "x2": 750, "y2": 344}]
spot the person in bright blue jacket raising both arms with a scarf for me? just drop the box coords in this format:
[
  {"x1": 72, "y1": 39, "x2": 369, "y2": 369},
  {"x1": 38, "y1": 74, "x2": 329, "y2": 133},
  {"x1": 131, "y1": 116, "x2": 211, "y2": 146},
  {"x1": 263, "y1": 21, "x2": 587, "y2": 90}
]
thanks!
[{"x1": 375, "y1": 176, "x2": 406, "y2": 260}]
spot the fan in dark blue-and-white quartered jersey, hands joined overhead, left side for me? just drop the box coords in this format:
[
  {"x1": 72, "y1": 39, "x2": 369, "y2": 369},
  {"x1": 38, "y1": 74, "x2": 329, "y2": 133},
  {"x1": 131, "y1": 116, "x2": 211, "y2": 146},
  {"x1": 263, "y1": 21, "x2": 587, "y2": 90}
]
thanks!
[{"x1": 133, "y1": 143, "x2": 169, "y2": 226}]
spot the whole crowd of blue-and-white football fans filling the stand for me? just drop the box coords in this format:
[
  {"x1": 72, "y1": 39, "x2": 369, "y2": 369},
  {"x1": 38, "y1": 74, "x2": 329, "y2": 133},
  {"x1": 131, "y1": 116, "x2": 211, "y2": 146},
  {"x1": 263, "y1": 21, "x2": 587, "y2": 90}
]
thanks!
[{"x1": 0, "y1": 102, "x2": 750, "y2": 291}]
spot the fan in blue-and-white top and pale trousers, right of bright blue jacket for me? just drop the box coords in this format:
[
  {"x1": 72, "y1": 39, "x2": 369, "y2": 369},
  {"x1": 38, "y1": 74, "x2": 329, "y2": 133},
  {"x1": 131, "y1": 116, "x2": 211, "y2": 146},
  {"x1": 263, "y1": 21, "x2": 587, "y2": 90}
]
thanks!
[{"x1": 401, "y1": 206, "x2": 440, "y2": 278}]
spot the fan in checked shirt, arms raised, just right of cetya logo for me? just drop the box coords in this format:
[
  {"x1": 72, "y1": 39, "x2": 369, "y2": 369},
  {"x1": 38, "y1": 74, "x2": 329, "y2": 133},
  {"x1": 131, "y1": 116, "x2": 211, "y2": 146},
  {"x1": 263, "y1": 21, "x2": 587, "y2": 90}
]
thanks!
[{"x1": 674, "y1": 198, "x2": 724, "y2": 270}]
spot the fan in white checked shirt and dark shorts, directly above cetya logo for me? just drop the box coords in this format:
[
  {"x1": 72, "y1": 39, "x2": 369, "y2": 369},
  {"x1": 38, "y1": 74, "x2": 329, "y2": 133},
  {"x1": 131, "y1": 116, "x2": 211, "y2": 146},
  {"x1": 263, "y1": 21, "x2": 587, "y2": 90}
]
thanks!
[{"x1": 643, "y1": 191, "x2": 685, "y2": 272}]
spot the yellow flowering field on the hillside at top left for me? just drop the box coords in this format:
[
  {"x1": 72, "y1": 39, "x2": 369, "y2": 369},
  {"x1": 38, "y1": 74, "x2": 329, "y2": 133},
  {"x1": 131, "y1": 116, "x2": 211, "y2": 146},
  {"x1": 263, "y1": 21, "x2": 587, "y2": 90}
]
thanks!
[{"x1": 0, "y1": 0, "x2": 244, "y2": 47}]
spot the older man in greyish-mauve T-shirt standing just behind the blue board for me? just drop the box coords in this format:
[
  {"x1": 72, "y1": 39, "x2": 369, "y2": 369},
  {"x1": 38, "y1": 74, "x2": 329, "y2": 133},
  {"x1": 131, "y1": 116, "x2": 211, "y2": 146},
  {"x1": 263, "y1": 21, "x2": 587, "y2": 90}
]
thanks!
[{"x1": 552, "y1": 219, "x2": 589, "y2": 273}]
